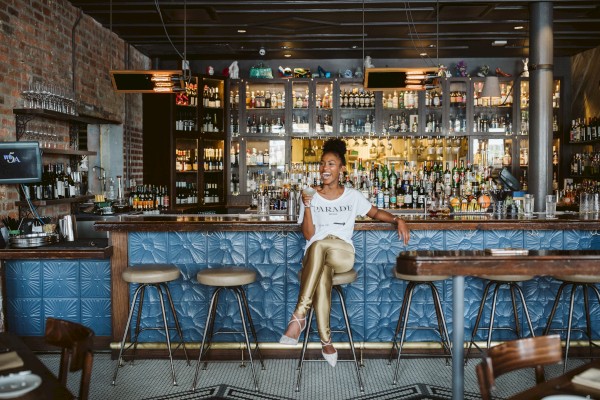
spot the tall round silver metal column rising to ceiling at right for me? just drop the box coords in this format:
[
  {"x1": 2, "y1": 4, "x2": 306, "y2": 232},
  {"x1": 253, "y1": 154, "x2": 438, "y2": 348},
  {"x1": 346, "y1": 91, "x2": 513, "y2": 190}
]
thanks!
[{"x1": 528, "y1": 1, "x2": 554, "y2": 211}]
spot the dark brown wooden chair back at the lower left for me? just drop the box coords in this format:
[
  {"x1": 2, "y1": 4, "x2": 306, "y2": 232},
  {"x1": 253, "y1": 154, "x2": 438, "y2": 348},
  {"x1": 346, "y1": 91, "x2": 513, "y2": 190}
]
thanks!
[{"x1": 45, "y1": 318, "x2": 94, "y2": 400}]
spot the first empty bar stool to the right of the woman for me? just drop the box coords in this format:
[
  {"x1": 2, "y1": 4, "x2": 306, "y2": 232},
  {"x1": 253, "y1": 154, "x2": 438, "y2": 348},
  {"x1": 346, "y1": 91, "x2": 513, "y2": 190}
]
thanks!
[{"x1": 389, "y1": 268, "x2": 452, "y2": 385}]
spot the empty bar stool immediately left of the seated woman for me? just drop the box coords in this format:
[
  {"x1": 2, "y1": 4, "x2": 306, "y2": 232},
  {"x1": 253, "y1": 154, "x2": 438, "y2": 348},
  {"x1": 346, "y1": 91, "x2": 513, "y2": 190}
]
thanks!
[{"x1": 192, "y1": 267, "x2": 265, "y2": 391}]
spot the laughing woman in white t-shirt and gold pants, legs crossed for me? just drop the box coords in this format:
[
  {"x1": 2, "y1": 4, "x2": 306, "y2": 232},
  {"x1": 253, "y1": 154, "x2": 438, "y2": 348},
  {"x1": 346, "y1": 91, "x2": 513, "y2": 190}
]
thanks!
[{"x1": 279, "y1": 139, "x2": 410, "y2": 367}]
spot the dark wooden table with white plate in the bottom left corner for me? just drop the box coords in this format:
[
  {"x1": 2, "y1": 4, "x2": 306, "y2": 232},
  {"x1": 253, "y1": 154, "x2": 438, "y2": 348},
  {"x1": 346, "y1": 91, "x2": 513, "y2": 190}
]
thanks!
[{"x1": 0, "y1": 332, "x2": 74, "y2": 400}]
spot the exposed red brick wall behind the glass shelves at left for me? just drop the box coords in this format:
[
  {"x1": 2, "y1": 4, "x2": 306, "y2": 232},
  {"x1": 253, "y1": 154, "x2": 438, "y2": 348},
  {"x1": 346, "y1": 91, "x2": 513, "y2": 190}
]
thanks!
[{"x1": 0, "y1": 0, "x2": 150, "y2": 218}]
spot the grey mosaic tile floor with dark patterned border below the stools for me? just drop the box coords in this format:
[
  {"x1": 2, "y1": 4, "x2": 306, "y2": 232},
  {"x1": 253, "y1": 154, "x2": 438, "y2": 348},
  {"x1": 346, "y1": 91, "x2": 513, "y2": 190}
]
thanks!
[{"x1": 40, "y1": 354, "x2": 585, "y2": 400}]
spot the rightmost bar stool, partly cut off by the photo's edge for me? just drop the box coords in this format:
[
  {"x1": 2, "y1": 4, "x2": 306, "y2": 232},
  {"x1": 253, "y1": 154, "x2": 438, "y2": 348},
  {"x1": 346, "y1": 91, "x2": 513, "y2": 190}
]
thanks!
[{"x1": 544, "y1": 275, "x2": 600, "y2": 373}]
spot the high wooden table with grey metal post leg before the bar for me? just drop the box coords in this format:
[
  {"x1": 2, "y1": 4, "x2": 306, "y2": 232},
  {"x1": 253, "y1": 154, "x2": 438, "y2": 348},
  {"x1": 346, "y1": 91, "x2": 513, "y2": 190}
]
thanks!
[{"x1": 396, "y1": 250, "x2": 600, "y2": 400}]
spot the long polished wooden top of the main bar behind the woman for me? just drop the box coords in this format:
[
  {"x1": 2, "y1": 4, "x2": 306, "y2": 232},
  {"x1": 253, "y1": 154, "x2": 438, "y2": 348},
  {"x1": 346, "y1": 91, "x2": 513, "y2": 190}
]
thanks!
[{"x1": 94, "y1": 212, "x2": 600, "y2": 232}]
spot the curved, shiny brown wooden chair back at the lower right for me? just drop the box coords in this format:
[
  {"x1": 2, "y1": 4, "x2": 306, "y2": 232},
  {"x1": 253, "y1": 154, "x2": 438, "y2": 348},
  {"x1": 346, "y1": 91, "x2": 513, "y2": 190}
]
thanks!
[{"x1": 476, "y1": 335, "x2": 562, "y2": 400}]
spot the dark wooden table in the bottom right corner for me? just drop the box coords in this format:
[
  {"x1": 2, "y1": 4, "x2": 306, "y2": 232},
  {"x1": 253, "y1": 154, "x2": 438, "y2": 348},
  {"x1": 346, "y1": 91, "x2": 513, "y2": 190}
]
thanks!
[{"x1": 508, "y1": 360, "x2": 600, "y2": 400}]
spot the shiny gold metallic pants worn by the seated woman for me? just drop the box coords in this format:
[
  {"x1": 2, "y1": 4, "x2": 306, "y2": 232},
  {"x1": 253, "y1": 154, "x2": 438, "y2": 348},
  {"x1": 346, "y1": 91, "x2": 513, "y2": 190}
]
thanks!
[{"x1": 295, "y1": 235, "x2": 354, "y2": 342}]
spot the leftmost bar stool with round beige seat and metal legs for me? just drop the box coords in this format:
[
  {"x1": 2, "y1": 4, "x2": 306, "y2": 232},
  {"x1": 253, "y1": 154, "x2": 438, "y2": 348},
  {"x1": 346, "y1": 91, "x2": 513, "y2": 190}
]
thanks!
[{"x1": 112, "y1": 264, "x2": 190, "y2": 386}]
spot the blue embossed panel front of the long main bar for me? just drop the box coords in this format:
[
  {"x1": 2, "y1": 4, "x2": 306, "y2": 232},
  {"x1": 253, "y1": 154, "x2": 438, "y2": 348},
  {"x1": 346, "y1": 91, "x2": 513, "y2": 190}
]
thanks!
[{"x1": 124, "y1": 229, "x2": 600, "y2": 343}]
